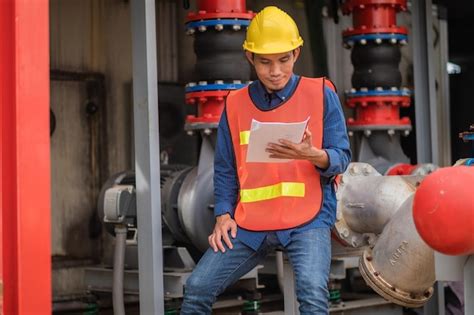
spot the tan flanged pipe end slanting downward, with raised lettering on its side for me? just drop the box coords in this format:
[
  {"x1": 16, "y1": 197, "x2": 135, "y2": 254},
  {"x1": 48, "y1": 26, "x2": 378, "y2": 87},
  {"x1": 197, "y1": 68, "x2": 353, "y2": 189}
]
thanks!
[{"x1": 359, "y1": 196, "x2": 435, "y2": 307}]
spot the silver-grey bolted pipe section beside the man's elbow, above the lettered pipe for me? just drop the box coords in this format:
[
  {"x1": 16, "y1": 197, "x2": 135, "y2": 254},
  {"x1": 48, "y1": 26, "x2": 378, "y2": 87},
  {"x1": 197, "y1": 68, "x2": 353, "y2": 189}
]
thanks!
[{"x1": 335, "y1": 162, "x2": 422, "y2": 247}]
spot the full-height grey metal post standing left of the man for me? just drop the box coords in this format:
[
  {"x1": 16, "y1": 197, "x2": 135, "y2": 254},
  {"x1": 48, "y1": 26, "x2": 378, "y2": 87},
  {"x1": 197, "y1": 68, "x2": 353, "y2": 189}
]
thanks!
[{"x1": 130, "y1": 0, "x2": 164, "y2": 314}]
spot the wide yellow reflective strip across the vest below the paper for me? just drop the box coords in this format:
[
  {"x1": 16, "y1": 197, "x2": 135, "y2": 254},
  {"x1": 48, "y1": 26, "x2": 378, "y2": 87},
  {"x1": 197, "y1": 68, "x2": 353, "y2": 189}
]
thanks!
[{"x1": 240, "y1": 182, "x2": 305, "y2": 202}]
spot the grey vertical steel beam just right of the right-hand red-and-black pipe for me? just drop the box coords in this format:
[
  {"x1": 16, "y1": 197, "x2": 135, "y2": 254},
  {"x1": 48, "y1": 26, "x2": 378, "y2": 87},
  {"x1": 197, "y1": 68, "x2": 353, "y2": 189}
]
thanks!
[{"x1": 411, "y1": 0, "x2": 440, "y2": 164}]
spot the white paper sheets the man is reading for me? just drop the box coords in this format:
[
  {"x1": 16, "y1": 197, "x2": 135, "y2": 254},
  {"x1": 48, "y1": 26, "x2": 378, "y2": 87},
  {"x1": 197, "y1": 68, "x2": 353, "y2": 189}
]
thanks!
[{"x1": 247, "y1": 117, "x2": 309, "y2": 163}]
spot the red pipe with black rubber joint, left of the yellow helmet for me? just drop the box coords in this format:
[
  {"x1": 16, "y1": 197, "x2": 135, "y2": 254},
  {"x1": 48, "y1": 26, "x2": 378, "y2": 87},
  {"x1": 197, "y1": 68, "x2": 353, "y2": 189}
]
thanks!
[{"x1": 185, "y1": 0, "x2": 254, "y2": 131}]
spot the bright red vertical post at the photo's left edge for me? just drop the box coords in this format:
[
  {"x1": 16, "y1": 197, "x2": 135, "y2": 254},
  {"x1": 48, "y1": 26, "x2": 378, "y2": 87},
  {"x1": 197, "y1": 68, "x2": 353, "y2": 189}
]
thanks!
[{"x1": 0, "y1": 0, "x2": 51, "y2": 315}]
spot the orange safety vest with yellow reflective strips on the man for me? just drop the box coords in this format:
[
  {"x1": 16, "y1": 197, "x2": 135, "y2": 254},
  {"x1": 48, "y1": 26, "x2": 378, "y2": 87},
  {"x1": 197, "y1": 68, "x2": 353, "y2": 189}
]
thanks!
[{"x1": 225, "y1": 77, "x2": 325, "y2": 231}]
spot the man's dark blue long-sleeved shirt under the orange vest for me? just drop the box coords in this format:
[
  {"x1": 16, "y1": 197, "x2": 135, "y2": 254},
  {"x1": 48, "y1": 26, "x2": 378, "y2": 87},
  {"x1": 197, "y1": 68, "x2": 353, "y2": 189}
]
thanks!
[{"x1": 214, "y1": 74, "x2": 351, "y2": 250}]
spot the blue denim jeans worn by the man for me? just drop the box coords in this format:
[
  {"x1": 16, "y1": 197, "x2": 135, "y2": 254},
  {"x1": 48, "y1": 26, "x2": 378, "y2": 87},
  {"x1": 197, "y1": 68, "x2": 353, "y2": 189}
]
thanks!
[{"x1": 181, "y1": 228, "x2": 331, "y2": 315}]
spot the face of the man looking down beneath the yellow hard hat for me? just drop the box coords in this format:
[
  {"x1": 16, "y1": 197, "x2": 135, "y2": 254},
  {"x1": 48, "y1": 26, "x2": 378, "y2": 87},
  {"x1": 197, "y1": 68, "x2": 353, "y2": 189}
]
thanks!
[{"x1": 246, "y1": 47, "x2": 300, "y2": 92}]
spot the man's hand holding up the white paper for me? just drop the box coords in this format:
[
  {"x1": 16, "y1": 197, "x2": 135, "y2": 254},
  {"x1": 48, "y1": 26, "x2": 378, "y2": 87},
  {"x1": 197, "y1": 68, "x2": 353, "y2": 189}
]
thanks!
[{"x1": 265, "y1": 129, "x2": 329, "y2": 169}]
